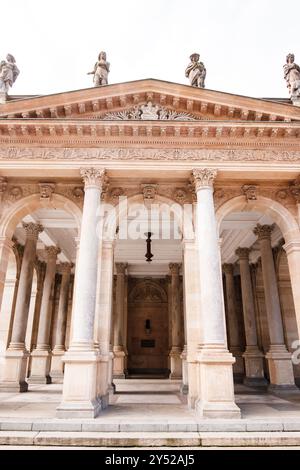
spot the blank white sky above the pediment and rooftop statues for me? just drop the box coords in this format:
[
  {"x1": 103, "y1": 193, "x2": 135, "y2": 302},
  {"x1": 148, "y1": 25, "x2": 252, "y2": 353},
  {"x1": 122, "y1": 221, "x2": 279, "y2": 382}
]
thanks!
[{"x1": 0, "y1": 0, "x2": 300, "y2": 97}]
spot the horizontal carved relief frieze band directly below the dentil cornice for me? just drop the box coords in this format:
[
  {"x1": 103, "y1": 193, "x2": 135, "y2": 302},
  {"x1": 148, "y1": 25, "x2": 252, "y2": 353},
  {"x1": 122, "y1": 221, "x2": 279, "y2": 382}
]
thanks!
[{"x1": 0, "y1": 147, "x2": 300, "y2": 162}]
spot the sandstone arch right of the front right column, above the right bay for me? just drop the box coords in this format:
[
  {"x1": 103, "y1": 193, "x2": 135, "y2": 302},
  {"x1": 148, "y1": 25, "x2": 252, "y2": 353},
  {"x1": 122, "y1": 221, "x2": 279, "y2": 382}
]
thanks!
[{"x1": 216, "y1": 196, "x2": 300, "y2": 243}]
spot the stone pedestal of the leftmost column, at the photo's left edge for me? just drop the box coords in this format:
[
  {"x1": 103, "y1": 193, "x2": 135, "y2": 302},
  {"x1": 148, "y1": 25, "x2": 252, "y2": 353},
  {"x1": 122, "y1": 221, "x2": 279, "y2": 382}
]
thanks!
[{"x1": 0, "y1": 348, "x2": 29, "y2": 392}]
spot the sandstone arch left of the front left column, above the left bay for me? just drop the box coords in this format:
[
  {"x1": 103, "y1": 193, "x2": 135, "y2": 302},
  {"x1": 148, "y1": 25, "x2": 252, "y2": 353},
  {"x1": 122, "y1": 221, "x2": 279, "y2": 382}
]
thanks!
[{"x1": 0, "y1": 194, "x2": 82, "y2": 238}]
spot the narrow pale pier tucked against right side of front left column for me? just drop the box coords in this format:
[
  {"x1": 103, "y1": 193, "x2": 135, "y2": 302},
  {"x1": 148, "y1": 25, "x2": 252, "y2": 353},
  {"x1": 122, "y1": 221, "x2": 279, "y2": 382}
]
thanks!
[{"x1": 96, "y1": 240, "x2": 114, "y2": 407}]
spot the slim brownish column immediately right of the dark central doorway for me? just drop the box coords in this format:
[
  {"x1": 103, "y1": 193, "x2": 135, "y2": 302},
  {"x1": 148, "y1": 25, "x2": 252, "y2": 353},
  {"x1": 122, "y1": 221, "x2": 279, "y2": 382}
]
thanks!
[{"x1": 169, "y1": 263, "x2": 183, "y2": 379}]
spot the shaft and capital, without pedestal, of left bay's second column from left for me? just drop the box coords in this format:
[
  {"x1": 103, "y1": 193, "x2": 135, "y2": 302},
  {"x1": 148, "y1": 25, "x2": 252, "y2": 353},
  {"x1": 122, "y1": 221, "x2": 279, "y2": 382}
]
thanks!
[{"x1": 36, "y1": 246, "x2": 60, "y2": 350}]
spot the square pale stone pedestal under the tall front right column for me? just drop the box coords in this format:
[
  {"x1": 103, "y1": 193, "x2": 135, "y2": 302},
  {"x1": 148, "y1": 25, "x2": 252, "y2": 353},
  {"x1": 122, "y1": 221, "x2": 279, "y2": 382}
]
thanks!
[{"x1": 195, "y1": 347, "x2": 241, "y2": 419}]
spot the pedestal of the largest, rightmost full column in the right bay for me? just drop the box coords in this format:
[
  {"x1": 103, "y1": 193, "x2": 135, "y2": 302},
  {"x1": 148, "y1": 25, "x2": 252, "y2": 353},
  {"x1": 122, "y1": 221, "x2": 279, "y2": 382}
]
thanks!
[{"x1": 266, "y1": 344, "x2": 295, "y2": 387}]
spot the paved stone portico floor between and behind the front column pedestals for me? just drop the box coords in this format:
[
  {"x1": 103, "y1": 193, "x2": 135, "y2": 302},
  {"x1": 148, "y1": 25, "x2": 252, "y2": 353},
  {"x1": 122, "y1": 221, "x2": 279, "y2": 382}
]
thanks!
[{"x1": 0, "y1": 379, "x2": 300, "y2": 422}]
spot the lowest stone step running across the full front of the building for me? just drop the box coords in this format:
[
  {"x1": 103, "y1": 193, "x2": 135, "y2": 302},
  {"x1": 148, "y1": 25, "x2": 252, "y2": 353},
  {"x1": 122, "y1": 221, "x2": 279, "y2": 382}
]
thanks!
[{"x1": 0, "y1": 431, "x2": 300, "y2": 447}]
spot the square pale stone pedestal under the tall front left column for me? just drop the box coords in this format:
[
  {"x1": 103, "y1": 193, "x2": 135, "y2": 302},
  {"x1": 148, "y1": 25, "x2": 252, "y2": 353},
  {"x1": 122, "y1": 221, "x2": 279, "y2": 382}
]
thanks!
[{"x1": 56, "y1": 348, "x2": 106, "y2": 418}]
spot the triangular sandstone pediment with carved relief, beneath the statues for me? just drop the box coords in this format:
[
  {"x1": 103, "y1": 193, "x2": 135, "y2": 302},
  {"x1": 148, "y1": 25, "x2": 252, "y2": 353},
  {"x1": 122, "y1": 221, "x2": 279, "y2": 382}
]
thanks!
[{"x1": 0, "y1": 79, "x2": 300, "y2": 122}]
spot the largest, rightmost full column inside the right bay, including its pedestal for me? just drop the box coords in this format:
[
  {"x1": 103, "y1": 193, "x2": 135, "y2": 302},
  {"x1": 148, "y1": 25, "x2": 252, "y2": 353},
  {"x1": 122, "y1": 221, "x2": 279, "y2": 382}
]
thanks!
[{"x1": 254, "y1": 224, "x2": 296, "y2": 390}]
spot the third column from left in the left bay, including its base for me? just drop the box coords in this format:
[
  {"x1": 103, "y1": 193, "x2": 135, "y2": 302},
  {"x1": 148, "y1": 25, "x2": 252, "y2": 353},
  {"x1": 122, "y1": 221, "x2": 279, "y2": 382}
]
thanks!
[{"x1": 50, "y1": 263, "x2": 73, "y2": 383}]
